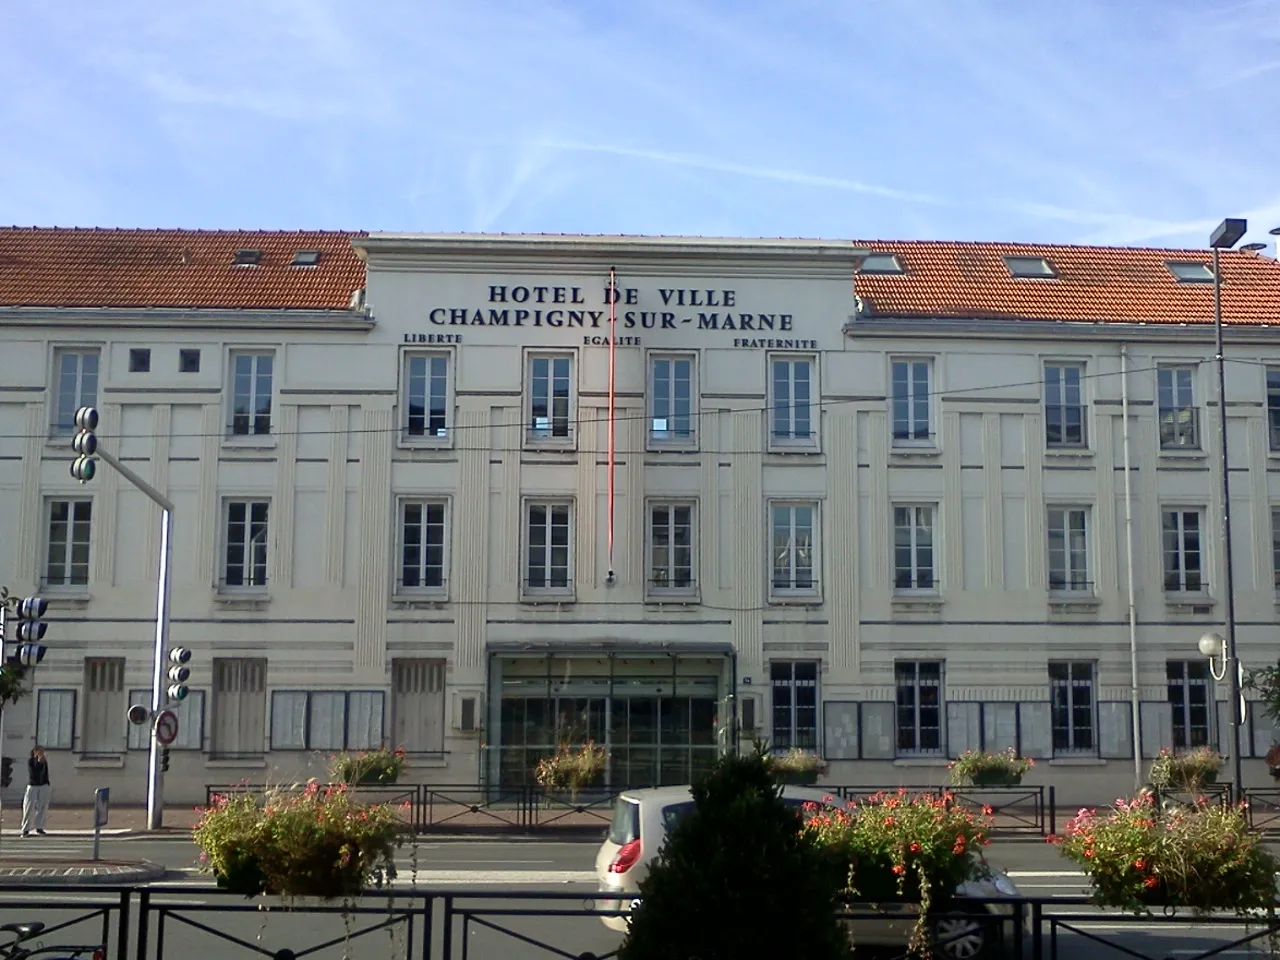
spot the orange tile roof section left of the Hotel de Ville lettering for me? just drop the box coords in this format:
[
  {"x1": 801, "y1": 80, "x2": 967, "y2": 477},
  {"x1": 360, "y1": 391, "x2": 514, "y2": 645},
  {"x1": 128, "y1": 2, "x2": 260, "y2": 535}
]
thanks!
[{"x1": 0, "y1": 227, "x2": 365, "y2": 310}]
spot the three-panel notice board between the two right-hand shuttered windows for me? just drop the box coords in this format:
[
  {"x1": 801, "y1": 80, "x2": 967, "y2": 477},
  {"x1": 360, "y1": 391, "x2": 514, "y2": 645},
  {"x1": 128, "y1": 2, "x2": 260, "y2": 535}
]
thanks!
[{"x1": 271, "y1": 690, "x2": 385, "y2": 750}]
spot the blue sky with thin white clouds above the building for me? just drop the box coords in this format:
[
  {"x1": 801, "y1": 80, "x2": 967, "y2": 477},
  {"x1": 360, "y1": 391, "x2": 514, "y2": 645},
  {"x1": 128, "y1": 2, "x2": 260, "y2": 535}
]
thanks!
[{"x1": 0, "y1": 0, "x2": 1280, "y2": 246}]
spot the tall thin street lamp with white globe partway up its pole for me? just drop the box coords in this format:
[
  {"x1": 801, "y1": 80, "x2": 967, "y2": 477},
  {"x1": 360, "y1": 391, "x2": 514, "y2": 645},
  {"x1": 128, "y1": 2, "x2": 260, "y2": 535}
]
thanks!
[{"x1": 1201, "y1": 216, "x2": 1249, "y2": 803}]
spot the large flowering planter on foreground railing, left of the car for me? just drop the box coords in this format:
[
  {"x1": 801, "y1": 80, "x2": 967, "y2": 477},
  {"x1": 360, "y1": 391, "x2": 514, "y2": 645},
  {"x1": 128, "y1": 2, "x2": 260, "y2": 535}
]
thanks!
[{"x1": 192, "y1": 781, "x2": 403, "y2": 900}]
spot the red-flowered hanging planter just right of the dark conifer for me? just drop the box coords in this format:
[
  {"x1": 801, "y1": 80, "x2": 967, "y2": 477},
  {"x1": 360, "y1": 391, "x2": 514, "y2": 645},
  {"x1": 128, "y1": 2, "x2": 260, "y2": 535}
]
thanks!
[{"x1": 805, "y1": 788, "x2": 991, "y2": 950}]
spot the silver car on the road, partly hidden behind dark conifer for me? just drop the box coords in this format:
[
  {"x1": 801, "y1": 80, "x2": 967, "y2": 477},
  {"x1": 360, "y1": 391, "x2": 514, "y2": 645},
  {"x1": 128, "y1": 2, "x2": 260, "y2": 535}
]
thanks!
[{"x1": 595, "y1": 786, "x2": 1018, "y2": 960}]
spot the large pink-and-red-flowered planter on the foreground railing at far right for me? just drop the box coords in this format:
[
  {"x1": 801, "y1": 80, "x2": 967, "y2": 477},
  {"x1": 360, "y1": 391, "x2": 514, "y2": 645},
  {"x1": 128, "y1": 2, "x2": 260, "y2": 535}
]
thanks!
[{"x1": 1050, "y1": 795, "x2": 1280, "y2": 914}]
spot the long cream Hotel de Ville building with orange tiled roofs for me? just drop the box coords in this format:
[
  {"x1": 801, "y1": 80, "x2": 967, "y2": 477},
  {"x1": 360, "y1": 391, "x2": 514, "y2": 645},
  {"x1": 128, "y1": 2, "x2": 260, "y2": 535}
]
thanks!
[{"x1": 0, "y1": 232, "x2": 1280, "y2": 801}]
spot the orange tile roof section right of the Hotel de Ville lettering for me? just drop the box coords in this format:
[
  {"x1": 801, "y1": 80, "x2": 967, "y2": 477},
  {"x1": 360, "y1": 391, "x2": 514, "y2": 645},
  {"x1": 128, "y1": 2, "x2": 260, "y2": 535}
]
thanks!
[{"x1": 856, "y1": 241, "x2": 1280, "y2": 324}]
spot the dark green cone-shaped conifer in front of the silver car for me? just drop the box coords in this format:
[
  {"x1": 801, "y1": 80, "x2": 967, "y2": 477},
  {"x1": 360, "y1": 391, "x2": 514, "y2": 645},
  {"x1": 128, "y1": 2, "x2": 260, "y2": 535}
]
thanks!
[{"x1": 618, "y1": 750, "x2": 849, "y2": 960}]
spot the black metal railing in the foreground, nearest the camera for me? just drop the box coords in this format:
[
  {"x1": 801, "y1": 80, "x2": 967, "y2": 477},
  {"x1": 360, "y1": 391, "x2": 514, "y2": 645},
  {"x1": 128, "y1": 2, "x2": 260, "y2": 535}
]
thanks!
[{"x1": 0, "y1": 884, "x2": 1280, "y2": 960}]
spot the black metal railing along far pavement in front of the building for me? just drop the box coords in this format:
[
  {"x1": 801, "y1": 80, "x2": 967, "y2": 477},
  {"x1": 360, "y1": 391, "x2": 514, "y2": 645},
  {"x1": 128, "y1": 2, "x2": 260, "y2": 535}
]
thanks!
[{"x1": 205, "y1": 783, "x2": 1057, "y2": 837}]
